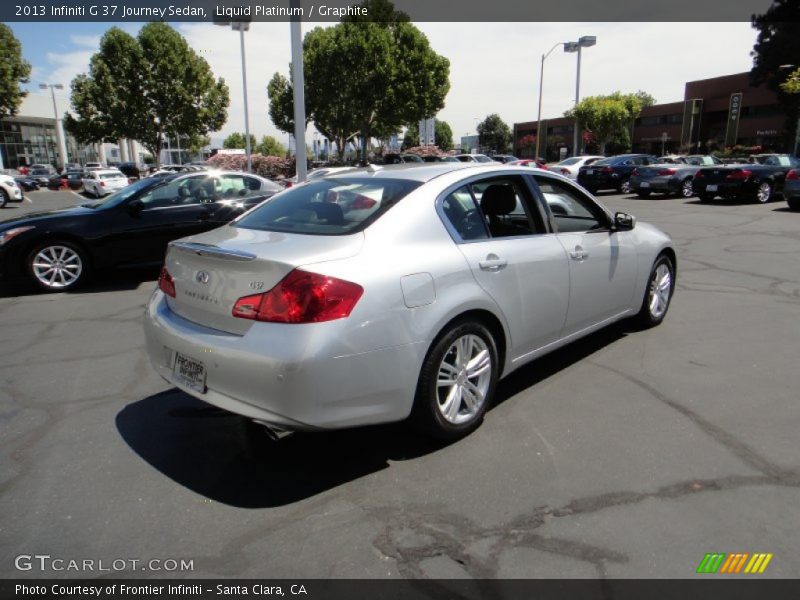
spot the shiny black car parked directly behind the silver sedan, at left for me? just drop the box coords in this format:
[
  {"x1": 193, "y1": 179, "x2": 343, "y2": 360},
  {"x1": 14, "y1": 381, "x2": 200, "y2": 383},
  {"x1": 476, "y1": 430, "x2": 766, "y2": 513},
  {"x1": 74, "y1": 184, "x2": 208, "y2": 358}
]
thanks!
[{"x1": 0, "y1": 172, "x2": 282, "y2": 292}]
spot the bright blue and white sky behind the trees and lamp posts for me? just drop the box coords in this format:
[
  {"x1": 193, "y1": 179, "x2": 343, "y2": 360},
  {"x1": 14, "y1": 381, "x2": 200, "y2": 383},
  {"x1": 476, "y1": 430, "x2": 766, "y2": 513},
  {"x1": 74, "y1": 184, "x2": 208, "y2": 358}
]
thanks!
[{"x1": 10, "y1": 22, "x2": 756, "y2": 145}]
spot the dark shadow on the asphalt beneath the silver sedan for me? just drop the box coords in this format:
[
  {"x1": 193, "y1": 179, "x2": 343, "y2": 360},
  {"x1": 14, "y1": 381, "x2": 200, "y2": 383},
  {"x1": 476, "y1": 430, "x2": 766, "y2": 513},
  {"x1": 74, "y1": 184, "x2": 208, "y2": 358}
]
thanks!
[{"x1": 116, "y1": 323, "x2": 632, "y2": 508}]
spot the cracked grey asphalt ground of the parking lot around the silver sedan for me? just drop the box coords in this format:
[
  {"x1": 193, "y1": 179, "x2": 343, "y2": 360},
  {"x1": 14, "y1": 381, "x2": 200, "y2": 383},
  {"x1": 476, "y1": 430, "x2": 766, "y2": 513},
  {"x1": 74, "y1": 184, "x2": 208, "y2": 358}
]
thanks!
[{"x1": 0, "y1": 192, "x2": 800, "y2": 578}]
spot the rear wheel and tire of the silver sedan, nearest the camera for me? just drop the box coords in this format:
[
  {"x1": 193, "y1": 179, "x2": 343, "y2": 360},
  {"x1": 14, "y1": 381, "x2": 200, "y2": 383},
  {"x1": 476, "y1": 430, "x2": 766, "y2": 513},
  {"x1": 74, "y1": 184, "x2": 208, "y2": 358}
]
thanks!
[{"x1": 411, "y1": 320, "x2": 500, "y2": 441}]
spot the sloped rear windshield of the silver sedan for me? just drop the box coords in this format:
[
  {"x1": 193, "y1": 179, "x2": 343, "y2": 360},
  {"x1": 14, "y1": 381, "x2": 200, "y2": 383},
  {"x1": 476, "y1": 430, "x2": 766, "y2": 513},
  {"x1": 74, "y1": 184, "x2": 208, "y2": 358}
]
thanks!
[{"x1": 234, "y1": 178, "x2": 420, "y2": 235}]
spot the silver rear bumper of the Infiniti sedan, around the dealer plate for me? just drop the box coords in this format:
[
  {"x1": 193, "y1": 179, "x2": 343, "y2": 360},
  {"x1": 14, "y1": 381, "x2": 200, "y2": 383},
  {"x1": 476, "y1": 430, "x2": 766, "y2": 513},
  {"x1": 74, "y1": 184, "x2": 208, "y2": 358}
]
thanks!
[{"x1": 145, "y1": 290, "x2": 425, "y2": 430}]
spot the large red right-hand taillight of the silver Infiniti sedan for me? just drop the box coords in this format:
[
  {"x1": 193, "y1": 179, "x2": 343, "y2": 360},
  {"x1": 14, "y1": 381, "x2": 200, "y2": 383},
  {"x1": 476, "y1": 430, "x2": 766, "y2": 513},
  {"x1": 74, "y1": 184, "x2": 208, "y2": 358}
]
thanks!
[{"x1": 233, "y1": 269, "x2": 364, "y2": 323}]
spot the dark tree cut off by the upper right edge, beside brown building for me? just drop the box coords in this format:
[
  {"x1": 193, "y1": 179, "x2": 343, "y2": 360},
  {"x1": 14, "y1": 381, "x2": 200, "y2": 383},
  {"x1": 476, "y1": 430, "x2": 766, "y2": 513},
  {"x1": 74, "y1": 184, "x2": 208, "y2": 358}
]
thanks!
[{"x1": 750, "y1": 0, "x2": 800, "y2": 147}]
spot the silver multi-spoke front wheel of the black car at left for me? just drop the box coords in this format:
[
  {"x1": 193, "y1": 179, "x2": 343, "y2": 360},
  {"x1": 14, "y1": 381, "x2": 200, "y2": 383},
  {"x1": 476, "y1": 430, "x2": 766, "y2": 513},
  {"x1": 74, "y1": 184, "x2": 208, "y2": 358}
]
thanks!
[{"x1": 27, "y1": 240, "x2": 89, "y2": 292}]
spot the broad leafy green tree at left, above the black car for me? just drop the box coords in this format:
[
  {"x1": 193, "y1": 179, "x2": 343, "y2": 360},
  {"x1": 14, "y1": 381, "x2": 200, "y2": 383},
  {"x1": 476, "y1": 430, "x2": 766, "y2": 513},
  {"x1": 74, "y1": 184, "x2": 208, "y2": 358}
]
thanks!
[{"x1": 65, "y1": 23, "x2": 230, "y2": 166}]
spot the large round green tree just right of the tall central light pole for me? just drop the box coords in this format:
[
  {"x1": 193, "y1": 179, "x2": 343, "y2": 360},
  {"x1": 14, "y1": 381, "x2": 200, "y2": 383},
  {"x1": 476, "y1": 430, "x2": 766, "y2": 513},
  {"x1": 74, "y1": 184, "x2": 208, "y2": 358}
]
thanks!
[{"x1": 268, "y1": 0, "x2": 450, "y2": 158}]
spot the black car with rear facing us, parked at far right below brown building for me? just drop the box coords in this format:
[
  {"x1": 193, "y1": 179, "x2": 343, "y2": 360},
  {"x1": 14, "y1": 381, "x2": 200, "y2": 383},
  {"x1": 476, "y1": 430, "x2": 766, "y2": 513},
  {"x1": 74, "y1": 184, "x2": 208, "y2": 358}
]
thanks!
[{"x1": 694, "y1": 154, "x2": 800, "y2": 203}]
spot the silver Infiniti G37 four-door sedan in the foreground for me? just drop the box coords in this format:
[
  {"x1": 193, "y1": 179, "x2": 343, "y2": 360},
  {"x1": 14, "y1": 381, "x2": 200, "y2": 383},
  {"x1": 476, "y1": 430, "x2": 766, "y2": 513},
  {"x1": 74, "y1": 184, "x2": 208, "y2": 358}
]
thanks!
[{"x1": 145, "y1": 163, "x2": 676, "y2": 439}]
